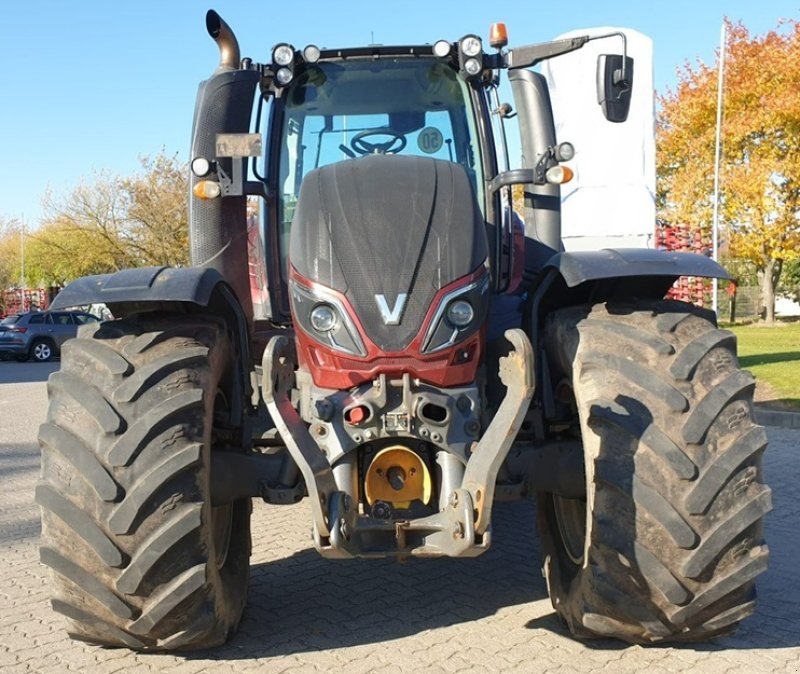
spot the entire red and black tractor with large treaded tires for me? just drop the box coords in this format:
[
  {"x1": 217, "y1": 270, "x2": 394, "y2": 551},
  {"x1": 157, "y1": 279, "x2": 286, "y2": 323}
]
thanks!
[{"x1": 36, "y1": 11, "x2": 771, "y2": 650}]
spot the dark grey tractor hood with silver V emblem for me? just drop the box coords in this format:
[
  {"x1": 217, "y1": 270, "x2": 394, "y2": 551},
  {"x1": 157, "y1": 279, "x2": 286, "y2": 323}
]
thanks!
[{"x1": 289, "y1": 155, "x2": 487, "y2": 352}]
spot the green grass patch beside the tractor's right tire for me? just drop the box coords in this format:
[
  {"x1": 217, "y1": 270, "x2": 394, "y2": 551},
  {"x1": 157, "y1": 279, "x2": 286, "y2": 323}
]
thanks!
[{"x1": 726, "y1": 322, "x2": 800, "y2": 409}]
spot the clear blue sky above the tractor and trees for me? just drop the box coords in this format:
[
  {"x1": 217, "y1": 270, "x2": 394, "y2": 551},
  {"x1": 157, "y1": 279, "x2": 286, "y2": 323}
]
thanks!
[{"x1": 0, "y1": 0, "x2": 800, "y2": 229}]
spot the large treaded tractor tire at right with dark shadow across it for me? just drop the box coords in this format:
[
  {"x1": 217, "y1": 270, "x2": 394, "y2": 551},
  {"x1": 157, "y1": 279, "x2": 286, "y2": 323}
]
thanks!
[{"x1": 538, "y1": 301, "x2": 771, "y2": 643}]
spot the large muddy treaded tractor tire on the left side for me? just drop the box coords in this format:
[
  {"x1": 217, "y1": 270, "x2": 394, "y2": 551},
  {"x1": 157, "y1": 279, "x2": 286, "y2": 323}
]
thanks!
[{"x1": 36, "y1": 316, "x2": 251, "y2": 650}]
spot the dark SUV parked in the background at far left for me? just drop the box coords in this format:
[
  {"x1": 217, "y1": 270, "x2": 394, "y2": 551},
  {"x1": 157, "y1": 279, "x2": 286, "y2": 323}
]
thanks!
[{"x1": 0, "y1": 311, "x2": 100, "y2": 363}]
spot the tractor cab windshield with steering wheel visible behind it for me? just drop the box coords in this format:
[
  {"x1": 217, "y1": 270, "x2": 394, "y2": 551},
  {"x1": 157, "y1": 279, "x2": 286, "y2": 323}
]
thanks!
[{"x1": 278, "y1": 57, "x2": 483, "y2": 261}]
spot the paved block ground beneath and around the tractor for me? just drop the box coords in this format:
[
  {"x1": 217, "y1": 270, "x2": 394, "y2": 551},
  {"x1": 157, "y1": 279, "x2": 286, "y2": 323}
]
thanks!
[{"x1": 0, "y1": 362, "x2": 800, "y2": 674}]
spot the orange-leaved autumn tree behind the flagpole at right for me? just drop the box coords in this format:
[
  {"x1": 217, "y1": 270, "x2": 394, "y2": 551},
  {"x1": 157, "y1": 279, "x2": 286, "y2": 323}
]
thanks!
[{"x1": 657, "y1": 21, "x2": 800, "y2": 322}]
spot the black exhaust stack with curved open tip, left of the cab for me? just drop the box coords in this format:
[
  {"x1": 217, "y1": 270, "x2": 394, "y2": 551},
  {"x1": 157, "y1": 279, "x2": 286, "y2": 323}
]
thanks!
[{"x1": 189, "y1": 11, "x2": 259, "y2": 330}]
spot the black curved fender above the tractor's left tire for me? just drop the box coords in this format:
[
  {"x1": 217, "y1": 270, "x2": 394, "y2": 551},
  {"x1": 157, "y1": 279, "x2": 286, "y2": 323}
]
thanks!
[{"x1": 50, "y1": 267, "x2": 252, "y2": 428}]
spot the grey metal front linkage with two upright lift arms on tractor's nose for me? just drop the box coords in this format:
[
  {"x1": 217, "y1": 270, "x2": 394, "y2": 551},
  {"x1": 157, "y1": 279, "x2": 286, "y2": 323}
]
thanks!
[{"x1": 262, "y1": 329, "x2": 535, "y2": 557}]
